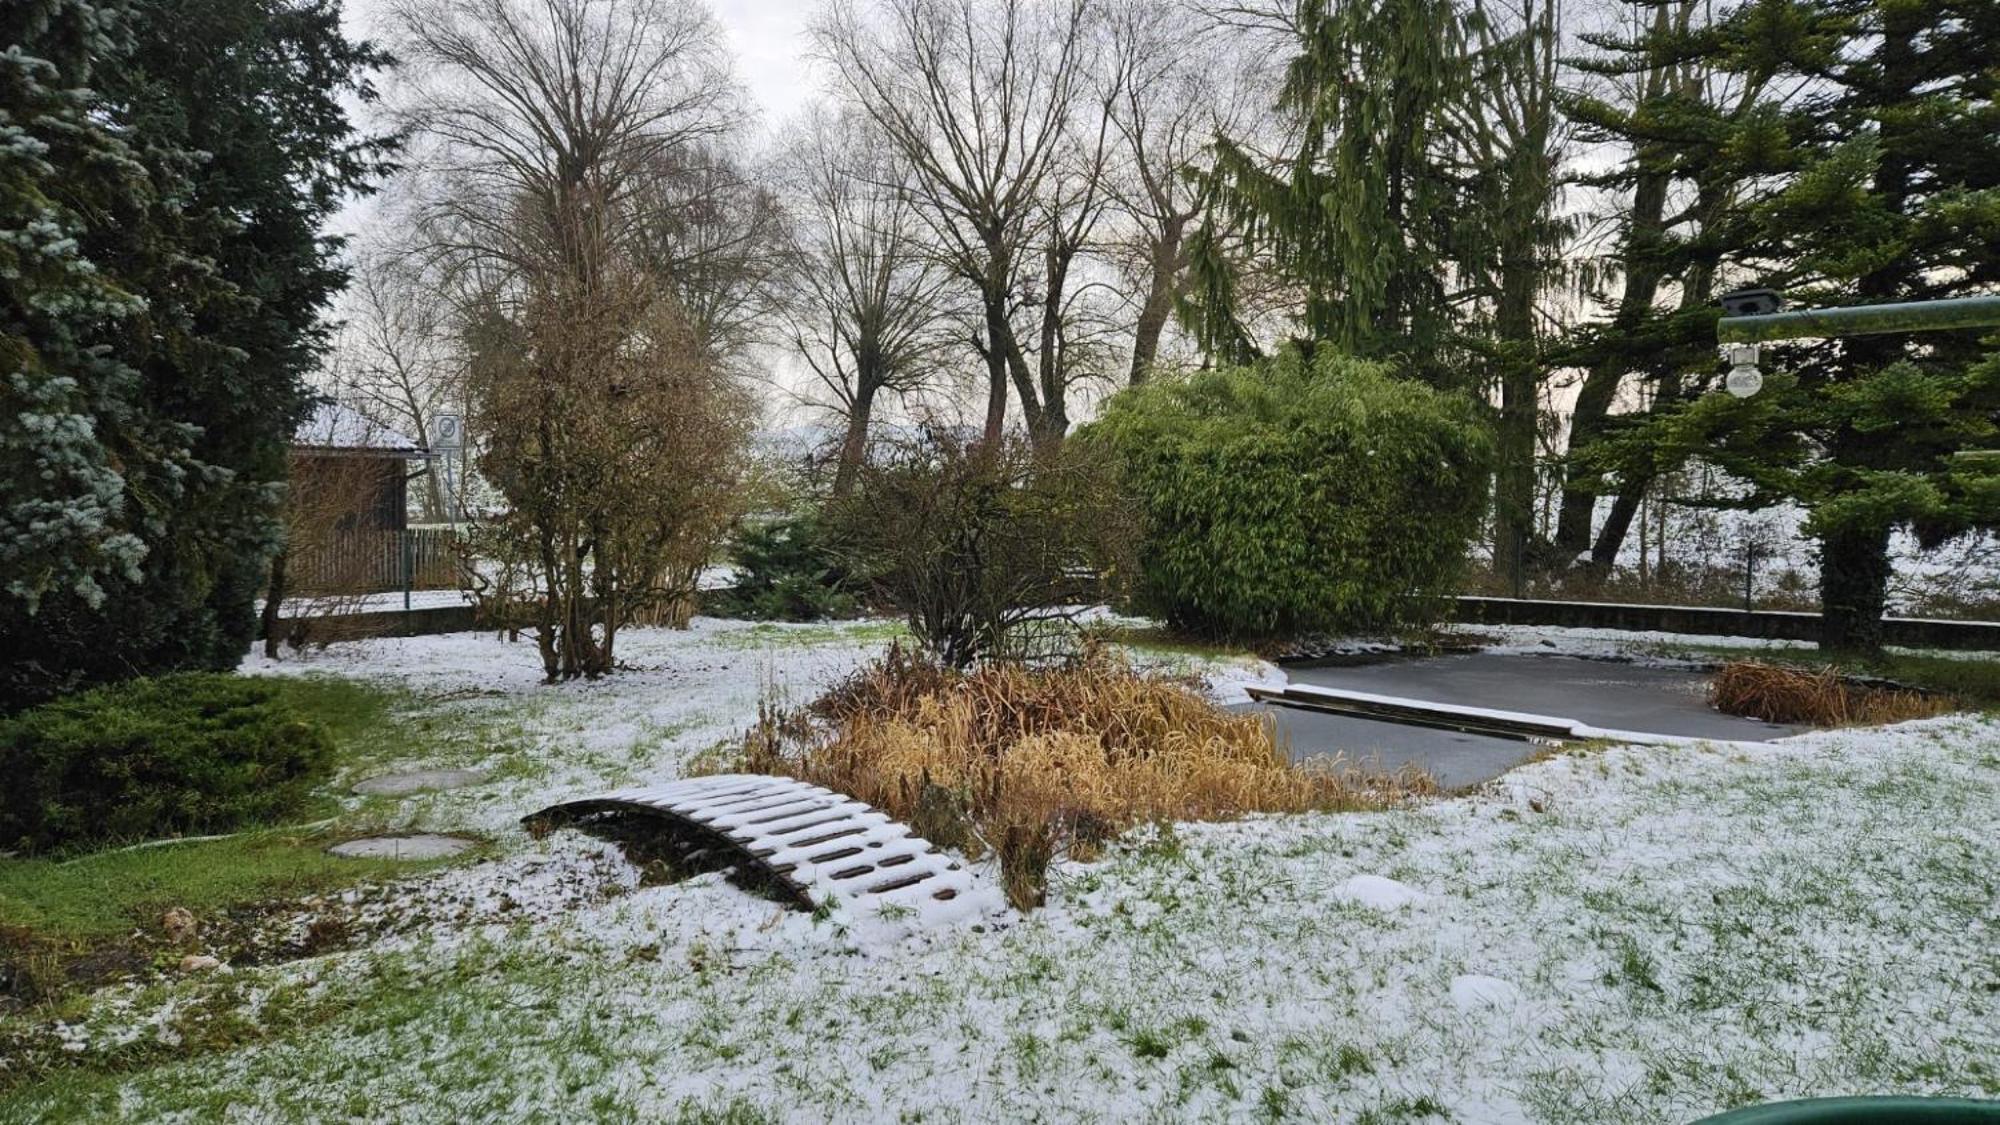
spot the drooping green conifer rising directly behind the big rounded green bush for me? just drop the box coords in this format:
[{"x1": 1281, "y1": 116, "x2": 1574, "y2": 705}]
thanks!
[{"x1": 1182, "y1": 0, "x2": 1468, "y2": 372}]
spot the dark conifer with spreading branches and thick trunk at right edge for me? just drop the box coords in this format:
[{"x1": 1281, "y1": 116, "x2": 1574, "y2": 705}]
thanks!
[{"x1": 1640, "y1": 0, "x2": 2000, "y2": 653}]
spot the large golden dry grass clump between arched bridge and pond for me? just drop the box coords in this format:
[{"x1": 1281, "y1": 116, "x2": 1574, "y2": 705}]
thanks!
[{"x1": 746, "y1": 647, "x2": 1436, "y2": 907}]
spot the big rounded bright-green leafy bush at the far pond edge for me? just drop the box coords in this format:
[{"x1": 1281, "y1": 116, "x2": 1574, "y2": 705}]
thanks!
[{"x1": 1086, "y1": 348, "x2": 1490, "y2": 639}]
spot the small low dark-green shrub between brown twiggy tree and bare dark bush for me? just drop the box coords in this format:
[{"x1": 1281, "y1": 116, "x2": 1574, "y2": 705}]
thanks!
[{"x1": 704, "y1": 512, "x2": 862, "y2": 621}]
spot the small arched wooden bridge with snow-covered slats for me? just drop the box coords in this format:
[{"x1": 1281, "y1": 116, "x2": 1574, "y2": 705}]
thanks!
[{"x1": 526, "y1": 773, "x2": 974, "y2": 915}]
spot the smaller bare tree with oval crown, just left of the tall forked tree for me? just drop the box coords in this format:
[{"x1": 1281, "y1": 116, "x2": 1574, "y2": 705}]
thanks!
[{"x1": 774, "y1": 108, "x2": 954, "y2": 496}]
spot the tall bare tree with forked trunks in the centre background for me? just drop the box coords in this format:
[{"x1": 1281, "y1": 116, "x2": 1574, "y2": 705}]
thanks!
[{"x1": 814, "y1": 0, "x2": 1104, "y2": 444}]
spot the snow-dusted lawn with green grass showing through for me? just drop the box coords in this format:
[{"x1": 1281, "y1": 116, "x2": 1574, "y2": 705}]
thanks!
[{"x1": 0, "y1": 621, "x2": 2000, "y2": 1123}]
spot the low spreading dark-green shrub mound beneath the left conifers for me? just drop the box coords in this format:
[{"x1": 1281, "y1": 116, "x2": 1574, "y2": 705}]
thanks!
[{"x1": 0, "y1": 673, "x2": 334, "y2": 853}]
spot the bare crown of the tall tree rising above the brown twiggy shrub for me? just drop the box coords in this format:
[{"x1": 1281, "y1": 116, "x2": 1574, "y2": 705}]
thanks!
[{"x1": 392, "y1": 0, "x2": 738, "y2": 278}]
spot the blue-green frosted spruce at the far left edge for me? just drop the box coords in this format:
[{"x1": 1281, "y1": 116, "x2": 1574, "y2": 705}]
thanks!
[{"x1": 0, "y1": 0, "x2": 194, "y2": 701}]
